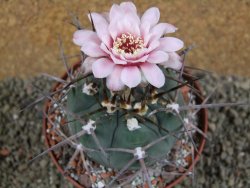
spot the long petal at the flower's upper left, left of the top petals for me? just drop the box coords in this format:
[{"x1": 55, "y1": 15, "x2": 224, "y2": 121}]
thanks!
[{"x1": 89, "y1": 12, "x2": 112, "y2": 47}]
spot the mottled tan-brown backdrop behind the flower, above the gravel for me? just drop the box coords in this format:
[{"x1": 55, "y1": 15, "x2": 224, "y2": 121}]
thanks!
[{"x1": 0, "y1": 0, "x2": 250, "y2": 79}]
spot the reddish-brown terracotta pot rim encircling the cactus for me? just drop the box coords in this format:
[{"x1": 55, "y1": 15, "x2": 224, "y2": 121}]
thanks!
[{"x1": 43, "y1": 62, "x2": 208, "y2": 188}]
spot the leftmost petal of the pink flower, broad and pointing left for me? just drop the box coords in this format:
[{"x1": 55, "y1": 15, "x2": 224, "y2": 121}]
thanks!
[{"x1": 73, "y1": 30, "x2": 101, "y2": 46}]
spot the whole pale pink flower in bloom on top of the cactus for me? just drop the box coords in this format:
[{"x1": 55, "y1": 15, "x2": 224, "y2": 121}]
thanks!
[{"x1": 73, "y1": 2, "x2": 183, "y2": 91}]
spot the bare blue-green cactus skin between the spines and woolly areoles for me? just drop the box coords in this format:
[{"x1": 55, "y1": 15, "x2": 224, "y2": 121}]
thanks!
[{"x1": 67, "y1": 72, "x2": 184, "y2": 170}]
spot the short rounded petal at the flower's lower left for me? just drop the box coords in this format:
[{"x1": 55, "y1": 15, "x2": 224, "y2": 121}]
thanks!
[{"x1": 92, "y1": 58, "x2": 115, "y2": 78}]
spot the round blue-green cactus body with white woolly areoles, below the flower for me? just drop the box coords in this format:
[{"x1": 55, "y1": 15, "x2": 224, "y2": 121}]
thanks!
[{"x1": 67, "y1": 71, "x2": 184, "y2": 170}]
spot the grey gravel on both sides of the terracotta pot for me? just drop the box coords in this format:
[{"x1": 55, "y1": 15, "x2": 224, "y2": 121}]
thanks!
[{"x1": 0, "y1": 75, "x2": 250, "y2": 188}]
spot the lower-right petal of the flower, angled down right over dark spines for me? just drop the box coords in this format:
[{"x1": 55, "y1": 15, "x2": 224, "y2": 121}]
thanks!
[{"x1": 140, "y1": 63, "x2": 165, "y2": 88}]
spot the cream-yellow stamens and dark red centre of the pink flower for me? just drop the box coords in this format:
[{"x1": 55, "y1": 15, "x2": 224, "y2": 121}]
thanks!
[{"x1": 113, "y1": 33, "x2": 144, "y2": 55}]
